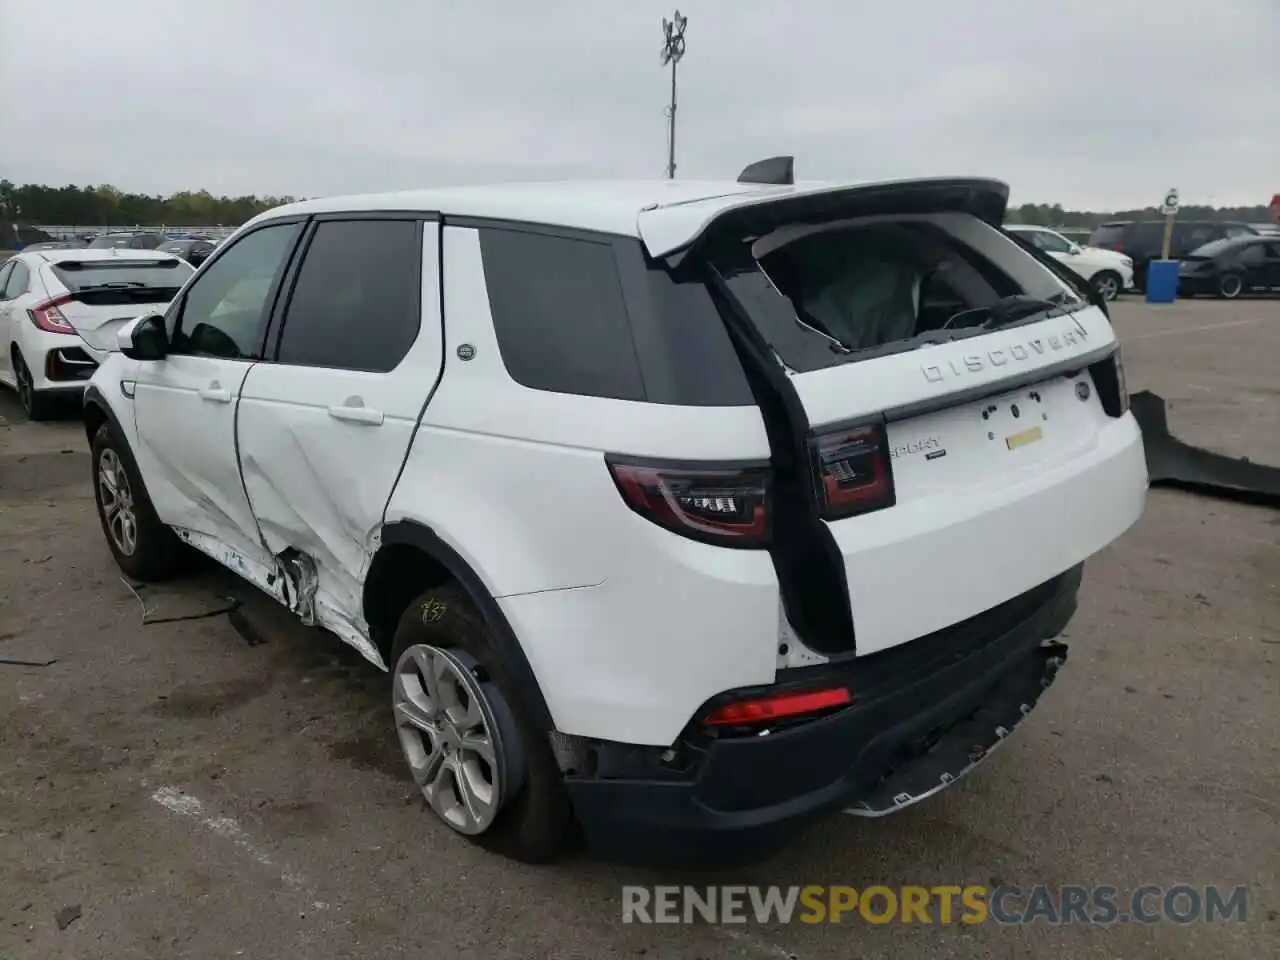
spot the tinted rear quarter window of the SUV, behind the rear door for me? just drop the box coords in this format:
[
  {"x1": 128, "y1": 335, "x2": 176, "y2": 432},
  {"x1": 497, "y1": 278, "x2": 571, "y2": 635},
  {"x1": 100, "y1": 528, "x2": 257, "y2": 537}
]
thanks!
[{"x1": 480, "y1": 229, "x2": 645, "y2": 401}]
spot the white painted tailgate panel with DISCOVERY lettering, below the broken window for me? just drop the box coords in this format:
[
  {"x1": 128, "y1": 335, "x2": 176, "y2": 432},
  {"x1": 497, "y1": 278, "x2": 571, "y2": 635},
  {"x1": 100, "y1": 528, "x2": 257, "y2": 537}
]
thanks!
[{"x1": 792, "y1": 307, "x2": 1146, "y2": 654}]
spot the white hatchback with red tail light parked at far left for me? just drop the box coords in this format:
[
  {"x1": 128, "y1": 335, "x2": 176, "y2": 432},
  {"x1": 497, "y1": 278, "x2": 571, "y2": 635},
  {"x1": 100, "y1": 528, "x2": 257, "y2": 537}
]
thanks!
[{"x1": 0, "y1": 247, "x2": 195, "y2": 420}]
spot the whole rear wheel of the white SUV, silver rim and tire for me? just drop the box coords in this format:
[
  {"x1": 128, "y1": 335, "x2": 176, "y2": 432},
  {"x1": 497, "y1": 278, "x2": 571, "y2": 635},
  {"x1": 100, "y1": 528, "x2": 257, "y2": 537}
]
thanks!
[{"x1": 392, "y1": 585, "x2": 573, "y2": 863}]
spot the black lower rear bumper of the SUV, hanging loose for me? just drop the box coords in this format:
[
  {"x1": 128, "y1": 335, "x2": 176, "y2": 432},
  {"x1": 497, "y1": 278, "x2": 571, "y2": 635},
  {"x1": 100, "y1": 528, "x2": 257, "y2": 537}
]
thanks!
[{"x1": 566, "y1": 567, "x2": 1082, "y2": 865}]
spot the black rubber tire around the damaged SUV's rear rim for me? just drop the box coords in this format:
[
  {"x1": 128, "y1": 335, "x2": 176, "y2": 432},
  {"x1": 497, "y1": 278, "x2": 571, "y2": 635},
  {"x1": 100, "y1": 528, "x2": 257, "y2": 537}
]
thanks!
[{"x1": 390, "y1": 584, "x2": 575, "y2": 864}]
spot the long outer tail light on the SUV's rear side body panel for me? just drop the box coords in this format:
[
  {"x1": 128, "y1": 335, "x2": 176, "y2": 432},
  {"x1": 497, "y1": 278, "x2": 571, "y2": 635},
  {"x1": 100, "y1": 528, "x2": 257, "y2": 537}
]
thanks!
[{"x1": 605, "y1": 457, "x2": 772, "y2": 547}]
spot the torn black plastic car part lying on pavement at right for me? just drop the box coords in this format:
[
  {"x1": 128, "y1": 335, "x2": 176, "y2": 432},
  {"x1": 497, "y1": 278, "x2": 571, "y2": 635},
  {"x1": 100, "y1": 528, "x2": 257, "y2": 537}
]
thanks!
[{"x1": 1129, "y1": 390, "x2": 1280, "y2": 507}]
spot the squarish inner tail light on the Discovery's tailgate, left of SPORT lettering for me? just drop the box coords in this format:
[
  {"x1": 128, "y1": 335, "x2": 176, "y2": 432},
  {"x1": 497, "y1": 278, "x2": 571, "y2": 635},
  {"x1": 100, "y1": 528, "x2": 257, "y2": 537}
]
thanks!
[{"x1": 810, "y1": 424, "x2": 895, "y2": 520}]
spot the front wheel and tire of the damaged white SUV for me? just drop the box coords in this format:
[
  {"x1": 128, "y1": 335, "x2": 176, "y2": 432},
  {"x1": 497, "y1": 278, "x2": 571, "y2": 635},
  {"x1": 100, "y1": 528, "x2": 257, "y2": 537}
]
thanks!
[{"x1": 90, "y1": 422, "x2": 191, "y2": 581}]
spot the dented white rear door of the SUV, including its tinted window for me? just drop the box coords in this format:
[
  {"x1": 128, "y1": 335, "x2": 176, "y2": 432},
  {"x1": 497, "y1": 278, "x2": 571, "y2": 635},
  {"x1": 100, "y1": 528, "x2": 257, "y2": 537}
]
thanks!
[{"x1": 237, "y1": 215, "x2": 442, "y2": 630}]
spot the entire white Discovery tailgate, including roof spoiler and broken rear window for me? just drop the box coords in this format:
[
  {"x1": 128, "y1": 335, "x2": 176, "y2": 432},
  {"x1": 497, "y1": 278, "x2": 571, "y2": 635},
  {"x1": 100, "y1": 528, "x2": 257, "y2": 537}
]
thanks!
[{"x1": 641, "y1": 180, "x2": 1146, "y2": 654}]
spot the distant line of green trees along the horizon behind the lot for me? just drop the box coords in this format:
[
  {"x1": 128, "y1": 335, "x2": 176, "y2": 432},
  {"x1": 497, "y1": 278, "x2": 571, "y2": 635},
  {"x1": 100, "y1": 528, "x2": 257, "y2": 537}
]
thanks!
[{"x1": 0, "y1": 179, "x2": 1270, "y2": 229}]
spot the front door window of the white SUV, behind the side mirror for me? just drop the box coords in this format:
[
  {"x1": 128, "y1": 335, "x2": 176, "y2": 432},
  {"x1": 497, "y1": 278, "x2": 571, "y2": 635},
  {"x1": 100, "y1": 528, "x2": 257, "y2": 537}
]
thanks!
[{"x1": 169, "y1": 223, "x2": 300, "y2": 360}]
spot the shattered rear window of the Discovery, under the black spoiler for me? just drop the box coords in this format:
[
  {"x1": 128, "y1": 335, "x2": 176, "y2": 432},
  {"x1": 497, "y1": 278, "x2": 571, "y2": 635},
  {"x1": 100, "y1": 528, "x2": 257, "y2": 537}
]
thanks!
[{"x1": 705, "y1": 215, "x2": 1088, "y2": 372}]
